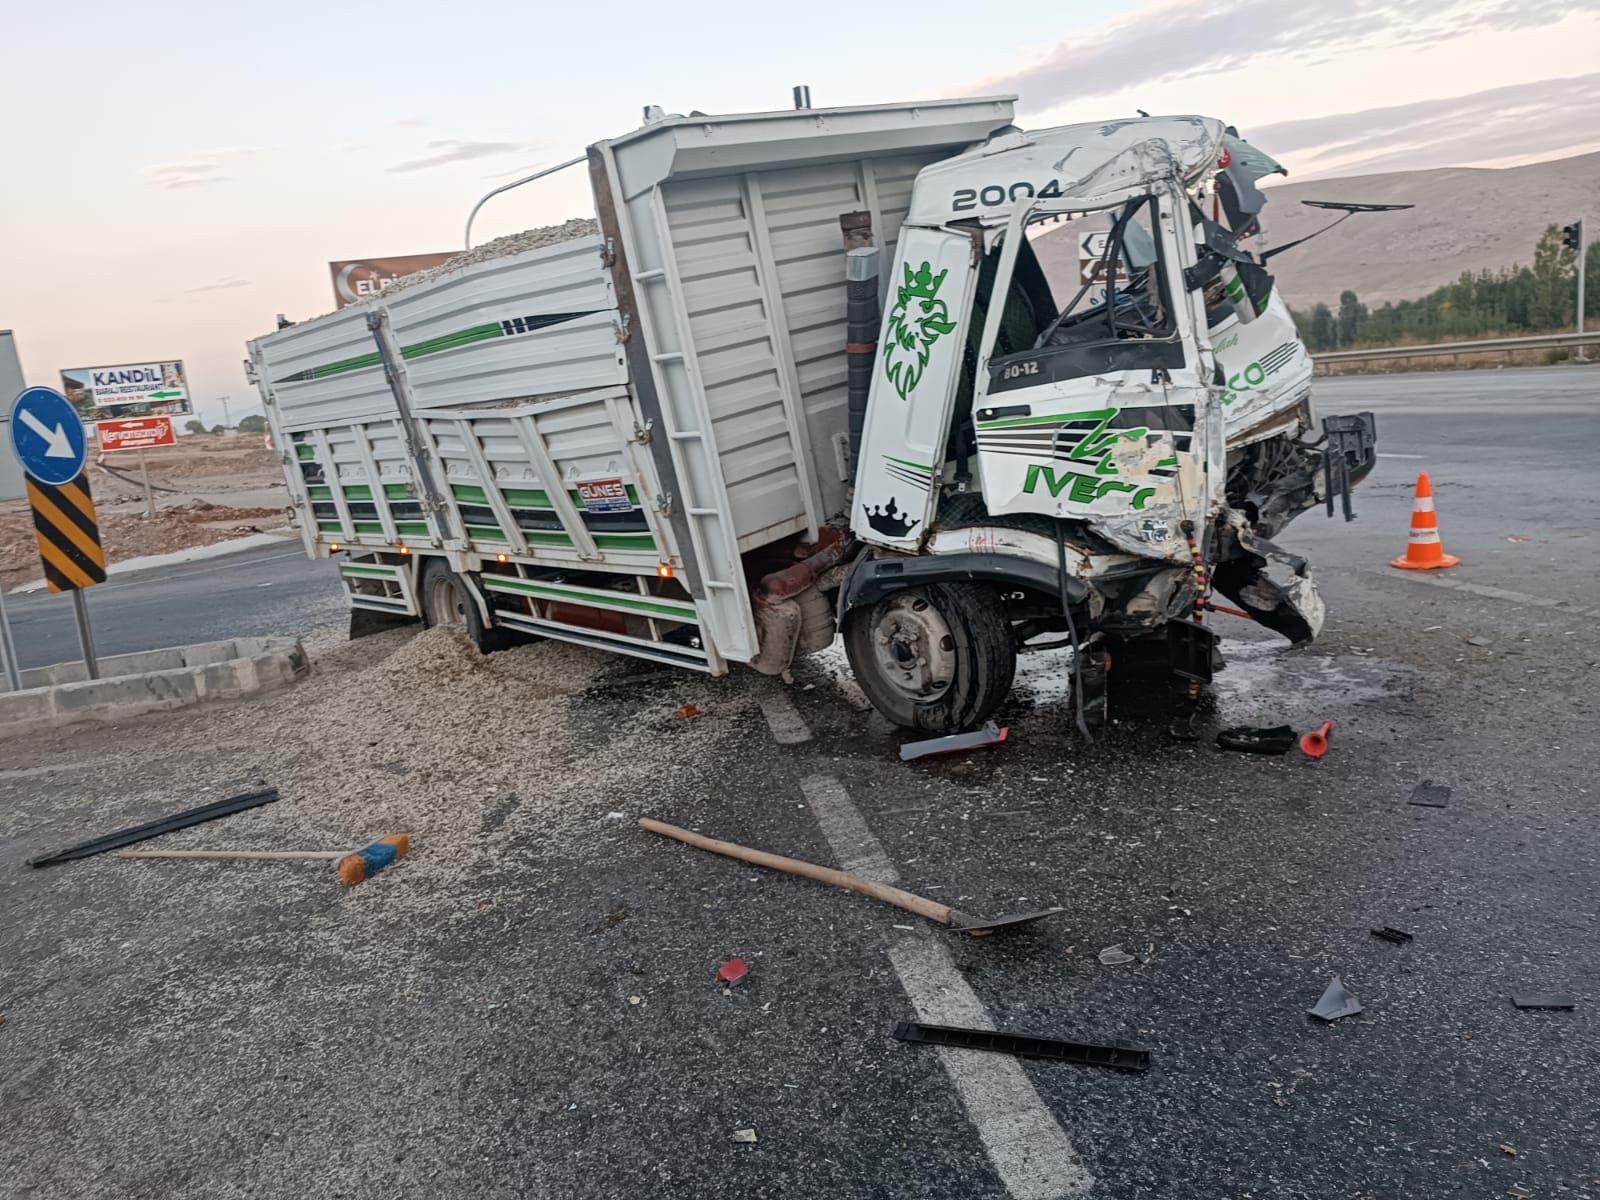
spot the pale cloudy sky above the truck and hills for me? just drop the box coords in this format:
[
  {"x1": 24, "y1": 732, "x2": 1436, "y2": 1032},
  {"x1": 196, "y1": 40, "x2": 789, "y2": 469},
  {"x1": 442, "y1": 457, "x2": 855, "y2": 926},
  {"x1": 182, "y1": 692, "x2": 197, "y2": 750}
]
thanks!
[{"x1": 0, "y1": 0, "x2": 1600, "y2": 419}]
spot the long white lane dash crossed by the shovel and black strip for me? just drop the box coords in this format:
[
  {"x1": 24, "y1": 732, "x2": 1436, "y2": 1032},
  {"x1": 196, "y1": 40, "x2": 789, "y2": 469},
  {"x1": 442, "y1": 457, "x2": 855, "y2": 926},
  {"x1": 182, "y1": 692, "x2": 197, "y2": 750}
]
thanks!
[{"x1": 800, "y1": 774, "x2": 1094, "y2": 1200}]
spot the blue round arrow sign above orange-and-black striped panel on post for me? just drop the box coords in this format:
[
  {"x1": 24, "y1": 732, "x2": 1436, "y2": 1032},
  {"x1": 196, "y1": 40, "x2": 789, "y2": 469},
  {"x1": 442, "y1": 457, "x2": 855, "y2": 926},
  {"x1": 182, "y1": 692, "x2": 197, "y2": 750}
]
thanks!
[{"x1": 11, "y1": 387, "x2": 106, "y2": 678}]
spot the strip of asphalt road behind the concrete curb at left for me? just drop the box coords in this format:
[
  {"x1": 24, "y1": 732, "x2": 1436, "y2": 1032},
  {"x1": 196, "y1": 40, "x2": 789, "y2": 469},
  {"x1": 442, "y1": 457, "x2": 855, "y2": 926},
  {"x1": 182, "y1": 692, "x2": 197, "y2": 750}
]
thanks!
[{"x1": 6, "y1": 541, "x2": 347, "y2": 669}]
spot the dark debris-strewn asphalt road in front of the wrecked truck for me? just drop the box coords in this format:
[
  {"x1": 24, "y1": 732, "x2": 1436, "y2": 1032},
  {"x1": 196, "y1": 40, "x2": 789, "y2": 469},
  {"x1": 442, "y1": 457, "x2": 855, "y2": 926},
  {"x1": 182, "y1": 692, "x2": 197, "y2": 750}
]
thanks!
[{"x1": 0, "y1": 370, "x2": 1600, "y2": 1200}]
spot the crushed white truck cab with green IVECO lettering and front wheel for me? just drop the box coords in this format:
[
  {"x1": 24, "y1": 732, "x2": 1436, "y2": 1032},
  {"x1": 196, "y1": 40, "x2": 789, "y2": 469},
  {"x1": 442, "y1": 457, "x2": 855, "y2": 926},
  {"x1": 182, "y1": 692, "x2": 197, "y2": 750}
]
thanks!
[{"x1": 840, "y1": 117, "x2": 1373, "y2": 731}]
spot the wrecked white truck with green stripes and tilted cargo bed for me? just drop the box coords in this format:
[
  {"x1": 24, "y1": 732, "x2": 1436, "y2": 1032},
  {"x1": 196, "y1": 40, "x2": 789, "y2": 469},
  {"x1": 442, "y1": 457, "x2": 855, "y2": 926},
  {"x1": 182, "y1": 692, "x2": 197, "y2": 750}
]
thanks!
[{"x1": 248, "y1": 98, "x2": 1374, "y2": 733}]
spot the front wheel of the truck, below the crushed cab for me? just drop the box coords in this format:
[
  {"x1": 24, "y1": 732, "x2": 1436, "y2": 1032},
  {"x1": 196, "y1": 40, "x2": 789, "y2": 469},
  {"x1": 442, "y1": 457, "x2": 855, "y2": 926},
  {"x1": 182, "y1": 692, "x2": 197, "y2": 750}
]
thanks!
[{"x1": 845, "y1": 582, "x2": 1016, "y2": 734}]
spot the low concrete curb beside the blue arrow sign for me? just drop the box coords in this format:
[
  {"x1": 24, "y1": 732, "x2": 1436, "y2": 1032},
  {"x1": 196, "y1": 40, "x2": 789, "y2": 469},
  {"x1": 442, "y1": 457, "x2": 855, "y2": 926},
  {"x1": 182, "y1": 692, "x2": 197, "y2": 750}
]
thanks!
[{"x1": 0, "y1": 637, "x2": 310, "y2": 739}]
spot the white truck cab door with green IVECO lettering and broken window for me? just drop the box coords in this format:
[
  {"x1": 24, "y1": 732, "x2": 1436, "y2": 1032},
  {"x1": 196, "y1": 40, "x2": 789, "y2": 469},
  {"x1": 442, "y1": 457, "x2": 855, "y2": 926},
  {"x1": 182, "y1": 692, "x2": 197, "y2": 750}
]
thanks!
[{"x1": 971, "y1": 195, "x2": 1221, "y2": 560}]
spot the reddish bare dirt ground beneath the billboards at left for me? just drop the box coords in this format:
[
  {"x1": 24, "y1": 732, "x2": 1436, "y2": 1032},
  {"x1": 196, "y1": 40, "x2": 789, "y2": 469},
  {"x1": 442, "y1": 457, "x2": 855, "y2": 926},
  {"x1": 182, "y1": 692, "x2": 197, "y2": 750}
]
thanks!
[{"x1": 0, "y1": 434, "x2": 288, "y2": 590}]
